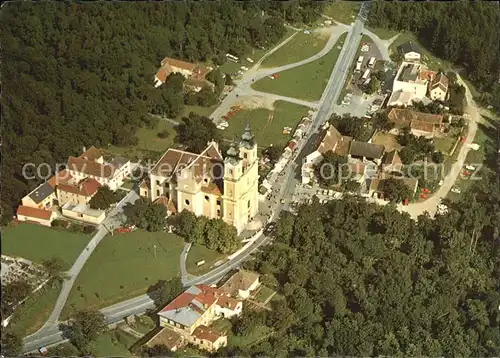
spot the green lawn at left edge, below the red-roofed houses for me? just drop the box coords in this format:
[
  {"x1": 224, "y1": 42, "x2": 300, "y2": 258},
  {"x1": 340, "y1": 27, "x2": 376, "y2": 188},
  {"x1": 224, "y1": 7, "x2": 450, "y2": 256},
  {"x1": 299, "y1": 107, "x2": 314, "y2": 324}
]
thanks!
[{"x1": 2, "y1": 223, "x2": 92, "y2": 269}]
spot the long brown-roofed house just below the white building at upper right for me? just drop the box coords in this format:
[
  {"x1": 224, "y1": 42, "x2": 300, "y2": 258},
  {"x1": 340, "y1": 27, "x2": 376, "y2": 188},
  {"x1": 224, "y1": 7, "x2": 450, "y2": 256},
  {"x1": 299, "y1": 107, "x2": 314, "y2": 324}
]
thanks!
[{"x1": 388, "y1": 108, "x2": 444, "y2": 137}]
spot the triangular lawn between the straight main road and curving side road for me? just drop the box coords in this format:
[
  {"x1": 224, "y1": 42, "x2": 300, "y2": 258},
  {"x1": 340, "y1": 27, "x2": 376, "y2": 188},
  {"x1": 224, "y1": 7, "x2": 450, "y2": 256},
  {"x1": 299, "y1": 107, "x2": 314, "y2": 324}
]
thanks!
[{"x1": 252, "y1": 33, "x2": 346, "y2": 101}]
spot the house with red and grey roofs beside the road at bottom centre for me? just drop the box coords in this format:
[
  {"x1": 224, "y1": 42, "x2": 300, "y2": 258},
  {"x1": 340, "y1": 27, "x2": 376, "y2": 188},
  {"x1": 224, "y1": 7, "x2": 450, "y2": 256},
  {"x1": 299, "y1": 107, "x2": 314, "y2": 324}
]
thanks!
[{"x1": 158, "y1": 285, "x2": 243, "y2": 352}]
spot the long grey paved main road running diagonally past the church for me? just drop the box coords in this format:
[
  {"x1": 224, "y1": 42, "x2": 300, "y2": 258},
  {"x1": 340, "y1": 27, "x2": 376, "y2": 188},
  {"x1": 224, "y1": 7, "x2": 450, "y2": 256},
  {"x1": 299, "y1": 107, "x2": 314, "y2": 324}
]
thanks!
[{"x1": 24, "y1": 3, "x2": 368, "y2": 352}]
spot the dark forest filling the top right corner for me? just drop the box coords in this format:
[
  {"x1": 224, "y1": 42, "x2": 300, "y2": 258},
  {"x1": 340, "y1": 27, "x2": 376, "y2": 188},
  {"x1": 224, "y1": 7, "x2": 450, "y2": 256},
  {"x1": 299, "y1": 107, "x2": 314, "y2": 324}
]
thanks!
[{"x1": 369, "y1": 1, "x2": 500, "y2": 111}]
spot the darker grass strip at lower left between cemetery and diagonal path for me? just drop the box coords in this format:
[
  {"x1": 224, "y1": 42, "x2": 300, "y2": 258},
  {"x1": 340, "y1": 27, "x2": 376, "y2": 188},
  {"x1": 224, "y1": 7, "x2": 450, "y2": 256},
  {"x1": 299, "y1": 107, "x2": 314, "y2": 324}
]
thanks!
[{"x1": 9, "y1": 282, "x2": 61, "y2": 336}]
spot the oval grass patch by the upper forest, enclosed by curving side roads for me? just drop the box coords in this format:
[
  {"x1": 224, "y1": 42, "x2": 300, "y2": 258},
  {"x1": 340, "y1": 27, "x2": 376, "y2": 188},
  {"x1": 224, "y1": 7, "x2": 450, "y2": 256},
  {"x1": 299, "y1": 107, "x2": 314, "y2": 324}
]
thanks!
[{"x1": 261, "y1": 32, "x2": 329, "y2": 67}]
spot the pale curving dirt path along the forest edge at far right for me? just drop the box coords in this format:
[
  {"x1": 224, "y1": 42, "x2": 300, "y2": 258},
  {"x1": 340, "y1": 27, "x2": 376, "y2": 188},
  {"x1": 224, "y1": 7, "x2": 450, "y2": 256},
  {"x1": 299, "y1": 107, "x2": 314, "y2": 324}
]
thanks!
[{"x1": 398, "y1": 75, "x2": 481, "y2": 219}]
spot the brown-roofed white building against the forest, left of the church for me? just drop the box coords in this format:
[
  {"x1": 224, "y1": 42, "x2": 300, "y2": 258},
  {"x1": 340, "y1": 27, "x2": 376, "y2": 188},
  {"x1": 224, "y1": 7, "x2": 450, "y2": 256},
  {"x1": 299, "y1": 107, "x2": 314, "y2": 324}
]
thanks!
[{"x1": 67, "y1": 147, "x2": 131, "y2": 191}]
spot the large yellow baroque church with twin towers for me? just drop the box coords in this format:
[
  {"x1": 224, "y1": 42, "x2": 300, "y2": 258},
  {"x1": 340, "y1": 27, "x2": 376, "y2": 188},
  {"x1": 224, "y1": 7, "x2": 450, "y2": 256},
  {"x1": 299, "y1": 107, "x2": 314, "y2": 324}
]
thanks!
[{"x1": 140, "y1": 125, "x2": 259, "y2": 233}]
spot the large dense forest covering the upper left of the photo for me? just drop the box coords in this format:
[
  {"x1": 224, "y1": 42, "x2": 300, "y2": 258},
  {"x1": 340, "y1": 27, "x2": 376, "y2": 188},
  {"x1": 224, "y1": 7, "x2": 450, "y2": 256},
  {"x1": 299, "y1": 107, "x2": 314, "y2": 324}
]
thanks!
[{"x1": 0, "y1": 0, "x2": 323, "y2": 223}]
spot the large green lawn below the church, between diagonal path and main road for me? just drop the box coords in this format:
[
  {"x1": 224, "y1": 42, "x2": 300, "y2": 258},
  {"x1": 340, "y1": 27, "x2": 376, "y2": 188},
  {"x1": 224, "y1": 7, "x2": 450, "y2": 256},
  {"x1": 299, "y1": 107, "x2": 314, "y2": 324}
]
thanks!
[{"x1": 63, "y1": 230, "x2": 184, "y2": 317}]
